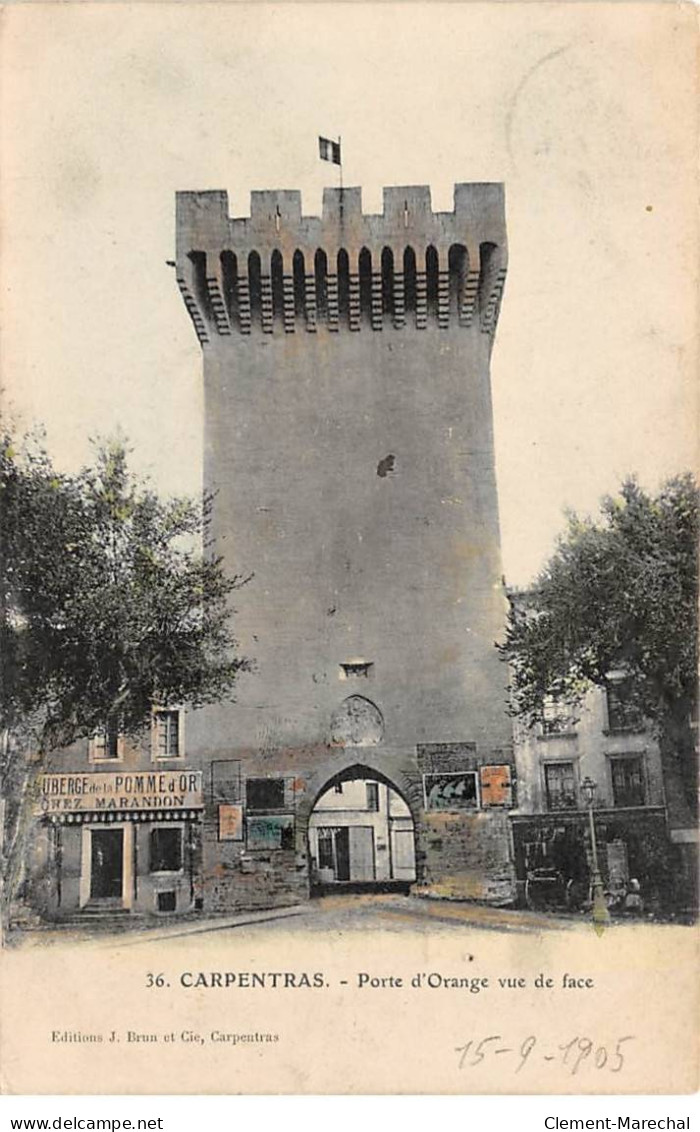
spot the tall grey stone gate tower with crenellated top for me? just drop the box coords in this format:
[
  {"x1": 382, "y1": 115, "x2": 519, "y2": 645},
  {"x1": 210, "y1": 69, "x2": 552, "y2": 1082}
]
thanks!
[{"x1": 177, "y1": 183, "x2": 512, "y2": 908}]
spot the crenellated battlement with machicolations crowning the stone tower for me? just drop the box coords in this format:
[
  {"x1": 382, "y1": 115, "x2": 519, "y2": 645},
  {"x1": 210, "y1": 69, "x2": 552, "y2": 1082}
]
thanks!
[{"x1": 172, "y1": 183, "x2": 507, "y2": 345}]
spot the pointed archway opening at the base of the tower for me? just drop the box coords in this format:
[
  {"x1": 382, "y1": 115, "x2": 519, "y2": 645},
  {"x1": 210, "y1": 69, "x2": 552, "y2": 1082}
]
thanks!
[{"x1": 308, "y1": 764, "x2": 416, "y2": 895}]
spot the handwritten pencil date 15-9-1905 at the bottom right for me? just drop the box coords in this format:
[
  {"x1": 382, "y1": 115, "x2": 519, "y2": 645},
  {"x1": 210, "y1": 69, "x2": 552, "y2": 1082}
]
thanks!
[{"x1": 454, "y1": 1034, "x2": 634, "y2": 1077}]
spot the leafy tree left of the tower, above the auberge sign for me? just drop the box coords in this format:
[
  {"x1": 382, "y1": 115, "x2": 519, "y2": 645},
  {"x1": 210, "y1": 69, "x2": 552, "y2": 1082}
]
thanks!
[{"x1": 0, "y1": 430, "x2": 249, "y2": 932}]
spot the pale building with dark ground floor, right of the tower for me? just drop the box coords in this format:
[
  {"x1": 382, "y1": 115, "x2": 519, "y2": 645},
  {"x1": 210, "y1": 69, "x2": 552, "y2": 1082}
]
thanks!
[{"x1": 511, "y1": 672, "x2": 684, "y2": 911}]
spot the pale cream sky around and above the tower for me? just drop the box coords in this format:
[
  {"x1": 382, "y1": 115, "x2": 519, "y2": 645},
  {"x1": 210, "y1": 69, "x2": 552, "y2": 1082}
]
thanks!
[{"x1": 0, "y1": 2, "x2": 700, "y2": 585}]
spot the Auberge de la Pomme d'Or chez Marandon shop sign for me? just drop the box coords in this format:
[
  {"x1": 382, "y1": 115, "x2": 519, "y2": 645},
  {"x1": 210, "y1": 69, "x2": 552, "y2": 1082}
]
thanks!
[{"x1": 35, "y1": 771, "x2": 204, "y2": 814}]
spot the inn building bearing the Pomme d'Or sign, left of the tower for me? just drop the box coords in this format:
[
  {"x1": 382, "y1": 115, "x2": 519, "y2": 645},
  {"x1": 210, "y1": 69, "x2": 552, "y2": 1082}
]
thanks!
[{"x1": 27, "y1": 710, "x2": 204, "y2": 919}]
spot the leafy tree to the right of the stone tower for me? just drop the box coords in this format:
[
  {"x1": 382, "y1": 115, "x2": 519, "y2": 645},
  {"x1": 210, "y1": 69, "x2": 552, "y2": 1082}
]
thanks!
[{"x1": 500, "y1": 474, "x2": 700, "y2": 824}]
